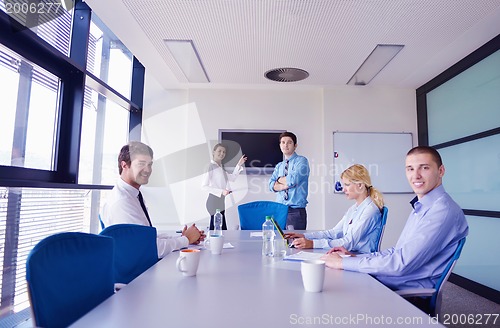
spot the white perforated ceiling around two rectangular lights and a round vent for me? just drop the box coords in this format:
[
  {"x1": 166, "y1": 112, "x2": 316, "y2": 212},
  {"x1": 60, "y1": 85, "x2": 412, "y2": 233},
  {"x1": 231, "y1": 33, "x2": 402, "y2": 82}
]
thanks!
[{"x1": 86, "y1": 0, "x2": 500, "y2": 88}]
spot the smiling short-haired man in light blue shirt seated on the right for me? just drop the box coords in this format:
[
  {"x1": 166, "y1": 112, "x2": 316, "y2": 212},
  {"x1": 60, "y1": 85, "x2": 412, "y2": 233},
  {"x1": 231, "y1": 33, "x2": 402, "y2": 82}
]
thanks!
[{"x1": 322, "y1": 146, "x2": 469, "y2": 290}]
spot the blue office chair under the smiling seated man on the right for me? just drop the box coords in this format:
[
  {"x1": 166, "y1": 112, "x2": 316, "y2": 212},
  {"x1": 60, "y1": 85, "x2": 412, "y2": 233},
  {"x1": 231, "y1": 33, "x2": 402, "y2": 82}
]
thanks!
[{"x1": 396, "y1": 237, "x2": 465, "y2": 317}]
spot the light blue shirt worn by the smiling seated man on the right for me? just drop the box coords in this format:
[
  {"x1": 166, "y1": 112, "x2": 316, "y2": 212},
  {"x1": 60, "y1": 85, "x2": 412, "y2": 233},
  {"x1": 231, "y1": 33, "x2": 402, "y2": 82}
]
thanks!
[{"x1": 342, "y1": 185, "x2": 469, "y2": 289}]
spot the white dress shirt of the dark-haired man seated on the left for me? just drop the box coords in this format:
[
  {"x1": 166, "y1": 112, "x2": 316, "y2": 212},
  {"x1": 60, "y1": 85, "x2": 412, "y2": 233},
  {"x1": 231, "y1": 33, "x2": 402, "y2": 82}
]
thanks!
[{"x1": 101, "y1": 178, "x2": 189, "y2": 258}]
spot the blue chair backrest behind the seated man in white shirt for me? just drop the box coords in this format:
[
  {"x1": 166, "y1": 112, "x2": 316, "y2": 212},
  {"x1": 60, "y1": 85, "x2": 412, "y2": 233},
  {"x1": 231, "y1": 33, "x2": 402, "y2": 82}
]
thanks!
[{"x1": 100, "y1": 224, "x2": 158, "y2": 284}]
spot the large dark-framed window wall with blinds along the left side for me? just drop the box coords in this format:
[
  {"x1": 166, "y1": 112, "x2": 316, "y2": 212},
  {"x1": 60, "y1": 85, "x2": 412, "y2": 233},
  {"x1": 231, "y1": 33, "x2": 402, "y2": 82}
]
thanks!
[{"x1": 0, "y1": 0, "x2": 144, "y2": 327}]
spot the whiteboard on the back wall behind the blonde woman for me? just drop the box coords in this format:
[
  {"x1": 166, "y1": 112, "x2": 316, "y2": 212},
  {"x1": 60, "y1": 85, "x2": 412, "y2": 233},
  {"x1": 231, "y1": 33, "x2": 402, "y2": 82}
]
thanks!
[{"x1": 333, "y1": 132, "x2": 413, "y2": 193}]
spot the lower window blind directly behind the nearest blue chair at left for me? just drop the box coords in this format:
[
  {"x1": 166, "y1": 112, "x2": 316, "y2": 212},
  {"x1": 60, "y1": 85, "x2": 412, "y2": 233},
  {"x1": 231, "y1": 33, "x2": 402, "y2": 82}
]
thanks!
[{"x1": 0, "y1": 187, "x2": 86, "y2": 312}]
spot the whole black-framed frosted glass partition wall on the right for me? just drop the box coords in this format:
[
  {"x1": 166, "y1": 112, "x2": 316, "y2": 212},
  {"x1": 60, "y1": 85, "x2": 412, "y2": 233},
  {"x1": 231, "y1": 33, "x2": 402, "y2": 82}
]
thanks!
[{"x1": 417, "y1": 35, "x2": 500, "y2": 302}]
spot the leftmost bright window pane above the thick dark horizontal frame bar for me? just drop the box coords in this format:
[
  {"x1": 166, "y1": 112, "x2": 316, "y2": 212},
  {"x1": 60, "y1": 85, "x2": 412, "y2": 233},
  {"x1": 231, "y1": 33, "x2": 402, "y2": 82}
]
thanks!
[{"x1": 0, "y1": 45, "x2": 59, "y2": 170}]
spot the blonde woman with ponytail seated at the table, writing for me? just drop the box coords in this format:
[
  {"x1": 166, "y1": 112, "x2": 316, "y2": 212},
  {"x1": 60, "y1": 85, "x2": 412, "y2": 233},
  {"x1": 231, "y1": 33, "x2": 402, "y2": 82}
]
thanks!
[{"x1": 285, "y1": 164, "x2": 384, "y2": 253}]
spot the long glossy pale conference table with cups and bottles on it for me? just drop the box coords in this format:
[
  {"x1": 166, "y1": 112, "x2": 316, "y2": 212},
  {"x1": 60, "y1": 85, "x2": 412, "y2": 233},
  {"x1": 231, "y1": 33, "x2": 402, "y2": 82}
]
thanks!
[{"x1": 71, "y1": 230, "x2": 441, "y2": 328}]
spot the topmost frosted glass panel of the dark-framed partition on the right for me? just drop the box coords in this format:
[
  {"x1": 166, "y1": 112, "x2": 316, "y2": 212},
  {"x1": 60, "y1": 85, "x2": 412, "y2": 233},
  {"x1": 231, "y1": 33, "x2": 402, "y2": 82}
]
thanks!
[{"x1": 427, "y1": 50, "x2": 500, "y2": 145}]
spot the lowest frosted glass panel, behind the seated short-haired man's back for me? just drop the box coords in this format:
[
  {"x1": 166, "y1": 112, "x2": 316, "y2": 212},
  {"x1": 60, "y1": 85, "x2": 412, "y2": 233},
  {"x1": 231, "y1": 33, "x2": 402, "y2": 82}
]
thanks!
[{"x1": 453, "y1": 216, "x2": 500, "y2": 290}]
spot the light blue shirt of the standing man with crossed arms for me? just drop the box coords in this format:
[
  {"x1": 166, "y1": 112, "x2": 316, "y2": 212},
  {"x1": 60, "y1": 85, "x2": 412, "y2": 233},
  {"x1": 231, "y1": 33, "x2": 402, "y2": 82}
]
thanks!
[{"x1": 269, "y1": 153, "x2": 309, "y2": 208}]
